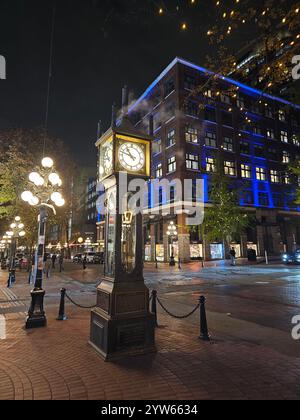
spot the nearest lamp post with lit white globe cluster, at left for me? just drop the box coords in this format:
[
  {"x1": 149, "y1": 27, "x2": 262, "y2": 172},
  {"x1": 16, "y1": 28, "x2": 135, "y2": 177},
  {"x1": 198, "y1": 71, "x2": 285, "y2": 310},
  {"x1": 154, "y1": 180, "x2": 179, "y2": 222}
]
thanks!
[{"x1": 22, "y1": 158, "x2": 65, "y2": 329}]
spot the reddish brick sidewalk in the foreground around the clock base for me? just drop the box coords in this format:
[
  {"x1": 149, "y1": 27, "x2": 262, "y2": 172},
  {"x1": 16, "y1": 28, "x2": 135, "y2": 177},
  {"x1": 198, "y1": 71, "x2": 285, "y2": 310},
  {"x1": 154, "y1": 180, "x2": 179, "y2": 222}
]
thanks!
[{"x1": 0, "y1": 308, "x2": 300, "y2": 400}]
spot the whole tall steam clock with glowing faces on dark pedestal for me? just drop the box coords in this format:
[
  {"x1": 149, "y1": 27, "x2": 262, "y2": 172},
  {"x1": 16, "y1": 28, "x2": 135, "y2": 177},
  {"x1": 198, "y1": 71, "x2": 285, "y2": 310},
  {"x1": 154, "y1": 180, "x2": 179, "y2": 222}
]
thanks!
[{"x1": 90, "y1": 117, "x2": 155, "y2": 360}]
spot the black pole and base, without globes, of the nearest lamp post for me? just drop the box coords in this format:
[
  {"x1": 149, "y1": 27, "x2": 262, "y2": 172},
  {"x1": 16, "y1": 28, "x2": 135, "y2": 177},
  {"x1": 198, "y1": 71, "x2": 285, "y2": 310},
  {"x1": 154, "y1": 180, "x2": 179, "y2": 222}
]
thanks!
[{"x1": 26, "y1": 207, "x2": 47, "y2": 329}]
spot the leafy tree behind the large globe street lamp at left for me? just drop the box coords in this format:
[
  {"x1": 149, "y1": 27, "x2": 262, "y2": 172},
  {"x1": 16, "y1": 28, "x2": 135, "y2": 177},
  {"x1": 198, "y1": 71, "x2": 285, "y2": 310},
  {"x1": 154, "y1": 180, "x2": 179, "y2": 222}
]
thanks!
[{"x1": 0, "y1": 129, "x2": 75, "y2": 243}]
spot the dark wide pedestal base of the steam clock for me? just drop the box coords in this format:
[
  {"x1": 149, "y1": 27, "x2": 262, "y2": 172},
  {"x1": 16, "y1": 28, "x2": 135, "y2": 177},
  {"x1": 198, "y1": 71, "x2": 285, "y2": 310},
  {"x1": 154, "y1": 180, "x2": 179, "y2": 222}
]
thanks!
[{"x1": 90, "y1": 279, "x2": 156, "y2": 361}]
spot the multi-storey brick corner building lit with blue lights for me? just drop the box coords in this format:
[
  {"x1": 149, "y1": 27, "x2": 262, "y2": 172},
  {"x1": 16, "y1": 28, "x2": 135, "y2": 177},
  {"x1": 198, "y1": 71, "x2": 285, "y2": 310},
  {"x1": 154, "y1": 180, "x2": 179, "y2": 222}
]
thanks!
[{"x1": 124, "y1": 58, "x2": 300, "y2": 261}]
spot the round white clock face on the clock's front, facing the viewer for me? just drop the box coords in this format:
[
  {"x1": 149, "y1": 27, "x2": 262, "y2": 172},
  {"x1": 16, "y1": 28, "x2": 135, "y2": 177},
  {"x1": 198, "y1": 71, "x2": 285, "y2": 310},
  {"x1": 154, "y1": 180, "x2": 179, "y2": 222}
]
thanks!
[{"x1": 119, "y1": 142, "x2": 145, "y2": 172}]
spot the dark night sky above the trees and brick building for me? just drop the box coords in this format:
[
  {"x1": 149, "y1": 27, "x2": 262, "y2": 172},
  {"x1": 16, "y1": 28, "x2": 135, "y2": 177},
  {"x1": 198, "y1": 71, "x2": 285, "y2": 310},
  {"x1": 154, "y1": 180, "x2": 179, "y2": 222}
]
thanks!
[{"x1": 0, "y1": 0, "x2": 260, "y2": 164}]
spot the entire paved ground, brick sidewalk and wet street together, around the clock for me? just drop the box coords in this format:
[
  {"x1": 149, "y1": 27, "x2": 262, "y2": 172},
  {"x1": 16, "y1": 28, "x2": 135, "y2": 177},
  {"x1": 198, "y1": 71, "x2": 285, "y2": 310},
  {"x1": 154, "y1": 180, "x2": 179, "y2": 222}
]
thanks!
[{"x1": 0, "y1": 266, "x2": 300, "y2": 400}]
